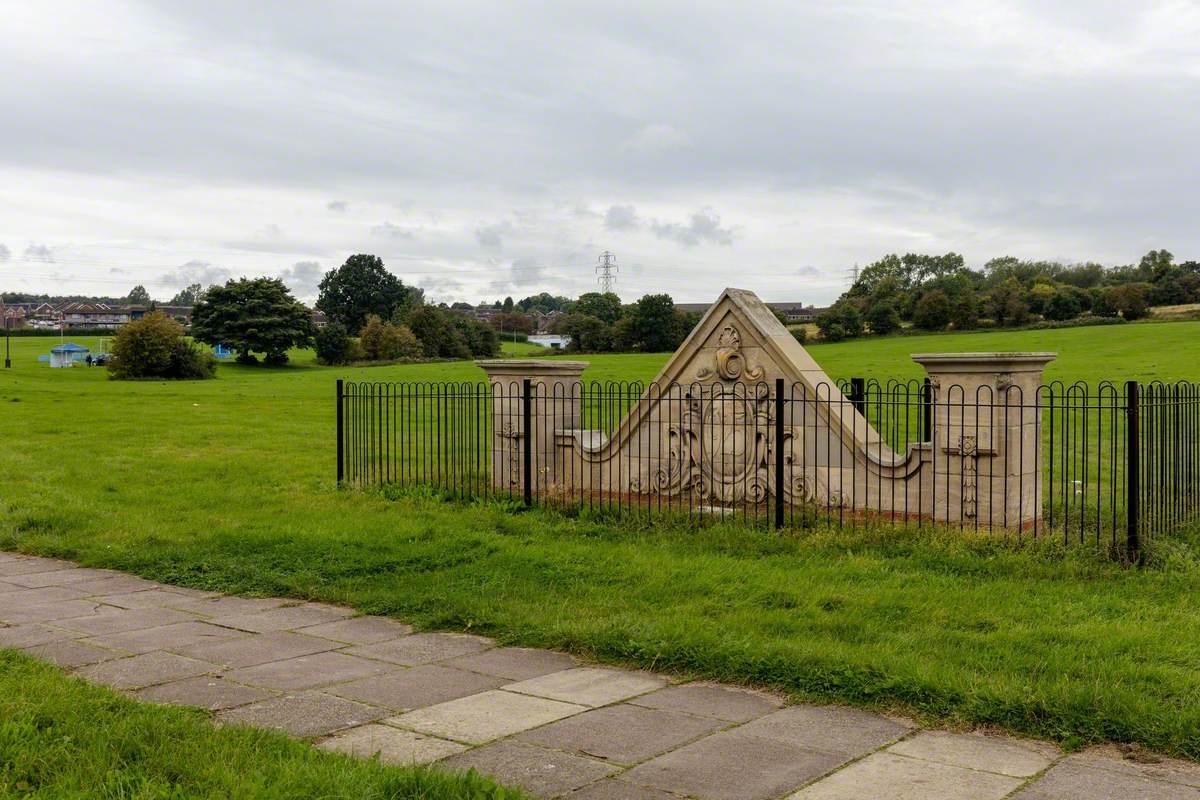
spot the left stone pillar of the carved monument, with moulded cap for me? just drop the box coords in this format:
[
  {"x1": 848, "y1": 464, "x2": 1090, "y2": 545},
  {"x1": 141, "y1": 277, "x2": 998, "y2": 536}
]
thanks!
[{"x1": 476, "y1": 359, "x2": 588, "y2": 493}]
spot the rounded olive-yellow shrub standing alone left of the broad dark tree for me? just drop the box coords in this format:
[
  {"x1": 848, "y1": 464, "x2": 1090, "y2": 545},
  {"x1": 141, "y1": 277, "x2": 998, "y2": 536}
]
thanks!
[{"x1": 108, "y1": 312, "x2": 217, "y2": 380}]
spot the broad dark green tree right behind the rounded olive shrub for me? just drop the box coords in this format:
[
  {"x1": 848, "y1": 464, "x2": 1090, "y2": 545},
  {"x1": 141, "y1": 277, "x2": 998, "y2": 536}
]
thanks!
[{"x1": 192, "y1": 278, "x2": 313, "y2": 365}]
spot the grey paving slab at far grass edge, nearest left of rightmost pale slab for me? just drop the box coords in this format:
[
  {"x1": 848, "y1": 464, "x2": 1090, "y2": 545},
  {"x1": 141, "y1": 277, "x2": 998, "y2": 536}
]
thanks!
[{"x1": 734, "y1": 705, "x2": 914, "y2": 758}]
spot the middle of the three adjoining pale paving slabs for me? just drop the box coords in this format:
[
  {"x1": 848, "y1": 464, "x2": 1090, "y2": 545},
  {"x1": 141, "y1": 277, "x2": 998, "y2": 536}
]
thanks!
[{"x1": 386, "y1": 690, "x2": 587, "y2": 745}]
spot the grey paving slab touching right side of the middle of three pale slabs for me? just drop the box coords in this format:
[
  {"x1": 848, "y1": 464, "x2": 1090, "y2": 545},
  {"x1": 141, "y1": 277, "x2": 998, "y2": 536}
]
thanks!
[{"x1": 518, "y1": 704, "x2": 726, "y2": 764}]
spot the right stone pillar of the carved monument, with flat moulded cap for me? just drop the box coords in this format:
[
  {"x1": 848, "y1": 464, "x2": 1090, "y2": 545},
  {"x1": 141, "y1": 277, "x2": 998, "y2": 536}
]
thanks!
[{"x1": 912, "y1": 353, "x2": 1056, "y2": 528}]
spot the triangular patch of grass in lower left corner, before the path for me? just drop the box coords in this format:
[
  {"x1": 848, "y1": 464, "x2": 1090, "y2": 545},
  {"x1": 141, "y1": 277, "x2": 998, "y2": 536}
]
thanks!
[{"x1": 0, "y1": 650, "x2": 526, "y2": 800}]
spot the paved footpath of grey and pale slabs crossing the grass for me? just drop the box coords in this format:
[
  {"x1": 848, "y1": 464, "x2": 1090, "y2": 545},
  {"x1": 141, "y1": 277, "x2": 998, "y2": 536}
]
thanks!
[{"x1": 0, "y1": 553, "x2": 1200, "y2": 800}]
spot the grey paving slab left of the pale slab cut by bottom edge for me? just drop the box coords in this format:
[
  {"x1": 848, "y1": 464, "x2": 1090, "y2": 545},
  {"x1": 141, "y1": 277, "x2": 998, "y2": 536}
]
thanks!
[{"x1": 623, "y1": 733, "x2": 849, "y2": 800}]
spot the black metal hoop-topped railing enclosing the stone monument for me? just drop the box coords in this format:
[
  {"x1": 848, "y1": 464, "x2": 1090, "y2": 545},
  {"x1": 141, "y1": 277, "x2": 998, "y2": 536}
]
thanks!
[{"x1": 337, "y1": 379, "x2": 1200, "y2": 558}]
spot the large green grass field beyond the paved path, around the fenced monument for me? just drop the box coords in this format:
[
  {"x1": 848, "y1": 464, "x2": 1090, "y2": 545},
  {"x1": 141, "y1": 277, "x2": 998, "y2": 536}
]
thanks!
[{"x1": 0, "y1": 323, "x2": 1200, "y2": 757}]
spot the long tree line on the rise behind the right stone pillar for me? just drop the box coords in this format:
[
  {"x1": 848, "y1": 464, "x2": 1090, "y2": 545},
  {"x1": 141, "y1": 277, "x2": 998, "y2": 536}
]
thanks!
[{"x1": 817, "y1": 249, "x2": 1200, "y2": 341}]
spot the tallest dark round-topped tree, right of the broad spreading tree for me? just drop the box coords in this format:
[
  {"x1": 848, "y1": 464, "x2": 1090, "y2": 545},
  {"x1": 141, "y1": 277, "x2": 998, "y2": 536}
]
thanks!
[{"x1": 317, "y1": 253, "x2": 413, "y2": 331}]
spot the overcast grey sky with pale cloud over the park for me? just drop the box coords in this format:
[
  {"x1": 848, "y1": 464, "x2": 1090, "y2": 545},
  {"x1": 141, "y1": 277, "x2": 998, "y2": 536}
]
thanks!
[{"x1": 0, "y1": 0, "x2": 1200, "y2": 303}]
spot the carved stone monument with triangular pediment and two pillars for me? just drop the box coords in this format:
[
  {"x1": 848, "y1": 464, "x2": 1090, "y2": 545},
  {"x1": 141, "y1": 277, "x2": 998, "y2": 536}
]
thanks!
[{"x1": 480, "y1": 289, "x2": 1055, "y2": 528}]
